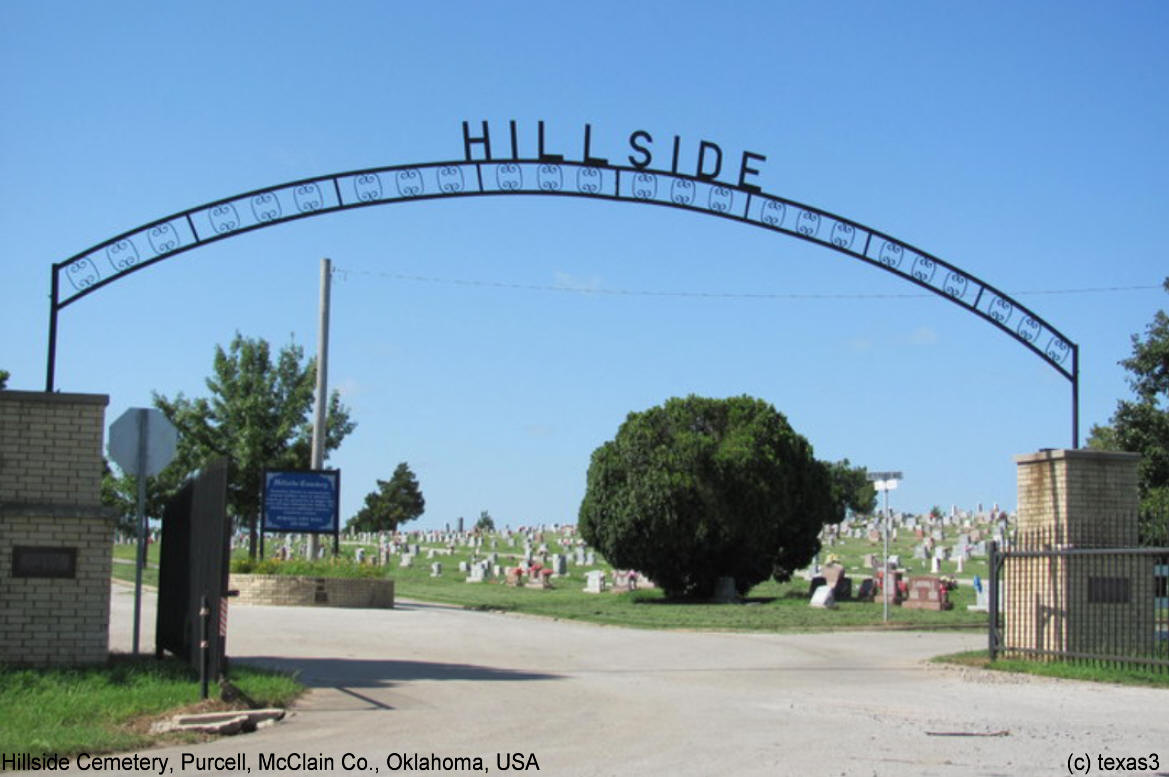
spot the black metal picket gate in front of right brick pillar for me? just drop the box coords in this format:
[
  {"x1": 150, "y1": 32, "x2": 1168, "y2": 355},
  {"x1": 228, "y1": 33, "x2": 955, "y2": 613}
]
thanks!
[{"x1": 988, "y1": 533, "x2": 1169, "y2": 672}]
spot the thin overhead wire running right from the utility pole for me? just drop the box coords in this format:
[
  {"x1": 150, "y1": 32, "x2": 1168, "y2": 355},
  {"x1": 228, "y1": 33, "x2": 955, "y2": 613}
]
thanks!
[{"x1": 333, "y1": 266, "x2": 1161, "y2": 299}]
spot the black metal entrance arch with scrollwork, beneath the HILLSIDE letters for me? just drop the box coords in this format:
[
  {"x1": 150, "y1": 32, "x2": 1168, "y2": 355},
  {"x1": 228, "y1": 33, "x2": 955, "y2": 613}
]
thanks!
[{"x1": 46, "y1": 153, "x2": 1079, "y2": 448}]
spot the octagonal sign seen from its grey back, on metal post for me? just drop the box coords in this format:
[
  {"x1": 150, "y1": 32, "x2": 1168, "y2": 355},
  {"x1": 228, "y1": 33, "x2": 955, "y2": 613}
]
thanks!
[{"x1": 109, "y1": 408, "x2": 179, "y2": 655}]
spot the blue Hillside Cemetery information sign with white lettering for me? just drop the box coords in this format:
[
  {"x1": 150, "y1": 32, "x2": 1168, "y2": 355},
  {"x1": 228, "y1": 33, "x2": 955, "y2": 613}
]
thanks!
[{"x1": 263, "y1": 470, "x2": 341, "y2": 534}]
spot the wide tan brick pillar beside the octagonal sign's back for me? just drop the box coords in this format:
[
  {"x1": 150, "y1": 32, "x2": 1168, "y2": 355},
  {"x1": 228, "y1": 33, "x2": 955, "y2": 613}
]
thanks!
[{"x1": 0, "y1": 391, "x2": 113, "y2": 665}]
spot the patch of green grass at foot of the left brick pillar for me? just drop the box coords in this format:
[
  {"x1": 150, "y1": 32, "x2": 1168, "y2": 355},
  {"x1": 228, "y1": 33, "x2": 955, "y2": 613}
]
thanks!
[{"x1": 0, "y1": 655, "x2": 304, "y2": 756}]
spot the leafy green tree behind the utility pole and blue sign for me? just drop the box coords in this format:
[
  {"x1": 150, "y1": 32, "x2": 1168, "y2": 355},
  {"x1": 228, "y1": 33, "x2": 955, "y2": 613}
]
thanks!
[{"x1": 154, "y1": 332, "x2": 357, "y2": 559}]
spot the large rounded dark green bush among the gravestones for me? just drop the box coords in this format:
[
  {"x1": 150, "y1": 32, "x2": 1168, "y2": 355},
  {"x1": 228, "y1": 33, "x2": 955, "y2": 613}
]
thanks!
[{"x1": 580, "y1": 396, "x2": 843, "y2": 597}]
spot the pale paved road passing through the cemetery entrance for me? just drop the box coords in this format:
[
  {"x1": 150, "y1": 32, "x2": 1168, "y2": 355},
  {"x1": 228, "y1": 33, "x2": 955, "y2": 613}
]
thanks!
[{"x1": 38, "y1": 587, "x2": 1169, "y2": 777}]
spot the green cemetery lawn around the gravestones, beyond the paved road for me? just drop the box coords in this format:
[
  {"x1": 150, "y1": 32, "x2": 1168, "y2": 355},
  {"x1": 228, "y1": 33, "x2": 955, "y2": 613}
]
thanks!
[{"x1": 113, "y1": 526, "x2": 987, "y2": 631}]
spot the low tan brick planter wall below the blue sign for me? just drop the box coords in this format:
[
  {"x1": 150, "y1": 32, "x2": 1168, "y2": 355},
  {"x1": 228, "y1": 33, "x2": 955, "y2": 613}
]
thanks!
[{"x1": 228, "y1": 574, "x2": 394, "y2": 609}]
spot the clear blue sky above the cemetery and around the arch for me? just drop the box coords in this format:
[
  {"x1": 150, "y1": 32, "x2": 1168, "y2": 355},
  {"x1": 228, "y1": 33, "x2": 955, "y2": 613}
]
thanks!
[{"x1": 0, "y1": 0, "x2": 1169, "y2": 527}]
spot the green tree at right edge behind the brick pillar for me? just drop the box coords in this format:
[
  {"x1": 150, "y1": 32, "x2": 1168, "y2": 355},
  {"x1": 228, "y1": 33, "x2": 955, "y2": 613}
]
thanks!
[{"x1": 1088, "y1": 278, "x2": 1169, "y2": 544}]
